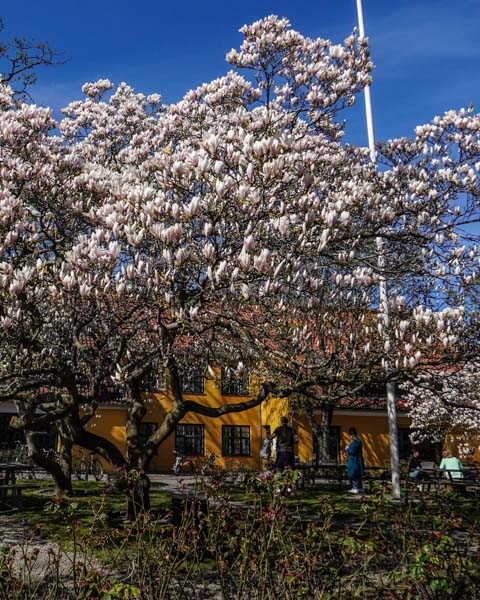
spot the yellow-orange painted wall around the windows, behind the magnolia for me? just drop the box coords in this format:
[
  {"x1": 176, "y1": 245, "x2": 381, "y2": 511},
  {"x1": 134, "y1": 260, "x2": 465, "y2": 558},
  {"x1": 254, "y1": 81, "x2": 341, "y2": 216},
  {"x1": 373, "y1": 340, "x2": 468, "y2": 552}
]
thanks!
[{"x1": 89, "y1": 371, "x2": 479, "y2": 472}]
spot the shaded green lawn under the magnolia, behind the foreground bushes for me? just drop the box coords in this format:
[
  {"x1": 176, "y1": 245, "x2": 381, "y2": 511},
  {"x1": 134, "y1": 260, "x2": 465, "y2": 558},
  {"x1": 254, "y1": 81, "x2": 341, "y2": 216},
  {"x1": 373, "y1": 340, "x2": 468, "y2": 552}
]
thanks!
[{"x1": 9, "y1": 480, "x2": 478, "y2": 543}]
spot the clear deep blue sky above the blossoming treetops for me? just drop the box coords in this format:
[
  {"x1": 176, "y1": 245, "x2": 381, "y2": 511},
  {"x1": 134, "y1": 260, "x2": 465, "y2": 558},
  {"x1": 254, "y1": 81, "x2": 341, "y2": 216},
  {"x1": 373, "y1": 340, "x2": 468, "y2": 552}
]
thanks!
[{"x1": 0, "y1": 0, "x2": 480, "y2": 145}]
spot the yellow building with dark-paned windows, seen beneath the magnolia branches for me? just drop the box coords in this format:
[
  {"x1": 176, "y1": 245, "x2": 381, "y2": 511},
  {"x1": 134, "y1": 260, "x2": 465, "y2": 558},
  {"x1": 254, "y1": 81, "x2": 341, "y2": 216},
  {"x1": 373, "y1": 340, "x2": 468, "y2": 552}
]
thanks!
[{"x1": 84, "y1": 367, "x2": 440, "y2": 472}]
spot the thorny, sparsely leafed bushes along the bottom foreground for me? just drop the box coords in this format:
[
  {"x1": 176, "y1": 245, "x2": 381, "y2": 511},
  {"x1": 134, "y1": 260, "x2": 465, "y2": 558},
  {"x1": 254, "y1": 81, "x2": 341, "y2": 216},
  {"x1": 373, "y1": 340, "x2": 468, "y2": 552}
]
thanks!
[{"x1": 0, "y1": 475, "x2": 480, "y2": 600}]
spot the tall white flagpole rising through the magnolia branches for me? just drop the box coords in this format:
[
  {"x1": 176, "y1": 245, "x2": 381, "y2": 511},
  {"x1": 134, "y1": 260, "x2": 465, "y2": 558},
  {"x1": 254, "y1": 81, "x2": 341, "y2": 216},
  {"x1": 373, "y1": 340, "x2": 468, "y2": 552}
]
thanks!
[{"x1": 357, "y1": 0, "x2": 401, "y2": 500}]
